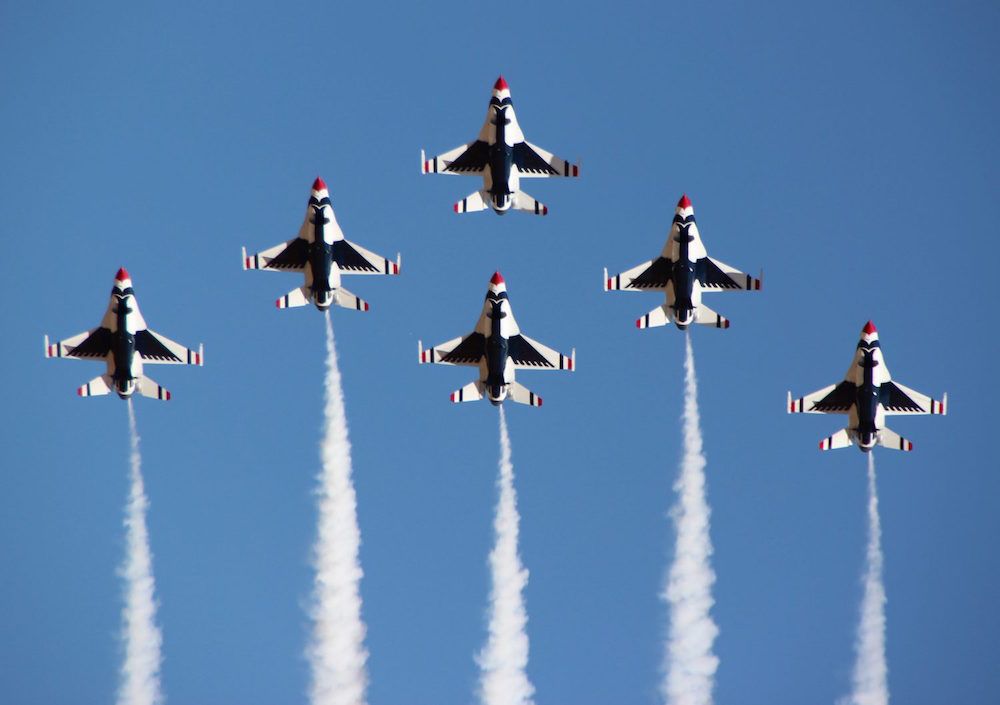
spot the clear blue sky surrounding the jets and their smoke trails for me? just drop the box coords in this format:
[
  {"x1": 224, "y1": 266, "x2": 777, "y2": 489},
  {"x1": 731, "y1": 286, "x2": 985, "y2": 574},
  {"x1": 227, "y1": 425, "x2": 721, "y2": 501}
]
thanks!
[{"x1": 0, "y1": 2, "x2": 1000, "y2": 705}]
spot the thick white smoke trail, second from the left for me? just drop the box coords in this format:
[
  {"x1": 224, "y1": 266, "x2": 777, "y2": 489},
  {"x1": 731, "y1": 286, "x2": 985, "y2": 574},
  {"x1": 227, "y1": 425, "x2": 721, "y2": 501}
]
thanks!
[{"x1": 308, "y1": 311, "x2": 368, "y2": 705}]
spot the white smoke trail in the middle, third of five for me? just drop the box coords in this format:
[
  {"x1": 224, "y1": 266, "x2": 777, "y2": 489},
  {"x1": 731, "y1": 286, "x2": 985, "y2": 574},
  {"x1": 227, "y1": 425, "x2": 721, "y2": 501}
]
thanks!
[{"x1": 476, "y1": 406, "x2": 535, "y2": 705}]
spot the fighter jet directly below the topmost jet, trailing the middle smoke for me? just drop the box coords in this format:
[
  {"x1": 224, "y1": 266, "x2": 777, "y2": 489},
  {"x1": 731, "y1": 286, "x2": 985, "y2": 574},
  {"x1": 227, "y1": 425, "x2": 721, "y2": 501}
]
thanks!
[{"x1": 417, "y1": 272, "x2": 576, "y2": 406}]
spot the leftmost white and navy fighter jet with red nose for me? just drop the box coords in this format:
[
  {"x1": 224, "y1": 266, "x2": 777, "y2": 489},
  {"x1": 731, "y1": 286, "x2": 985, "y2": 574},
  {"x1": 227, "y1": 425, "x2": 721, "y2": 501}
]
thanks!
[{"x1": 45, "y1": 267, "x2": 205, "y2": 401}]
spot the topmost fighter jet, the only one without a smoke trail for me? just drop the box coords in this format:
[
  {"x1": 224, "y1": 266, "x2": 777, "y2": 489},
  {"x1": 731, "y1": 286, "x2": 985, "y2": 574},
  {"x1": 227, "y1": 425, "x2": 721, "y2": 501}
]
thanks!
[{"x1": 420, "y1": 76, "x2": 580, "y2": 215}]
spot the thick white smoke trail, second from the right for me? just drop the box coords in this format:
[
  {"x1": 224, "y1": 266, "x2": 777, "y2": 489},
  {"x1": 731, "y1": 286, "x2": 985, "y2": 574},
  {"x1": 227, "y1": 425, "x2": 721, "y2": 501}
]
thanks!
[{"x1": 660, "y1": 336, "x2": 719, "y2": 705}]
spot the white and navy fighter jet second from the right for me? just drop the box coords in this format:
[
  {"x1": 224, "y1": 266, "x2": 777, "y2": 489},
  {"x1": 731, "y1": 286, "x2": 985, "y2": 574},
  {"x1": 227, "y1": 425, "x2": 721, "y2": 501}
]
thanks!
[{"x1": 604, "y1": 194, "x2": 764, "y2": 330}]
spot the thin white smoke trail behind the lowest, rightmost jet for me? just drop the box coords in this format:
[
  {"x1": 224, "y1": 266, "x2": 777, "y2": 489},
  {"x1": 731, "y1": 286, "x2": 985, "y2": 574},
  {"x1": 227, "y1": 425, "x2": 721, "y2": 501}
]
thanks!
[{"x1": 849, "y1": 453, "x2": 889, "y2": 705}]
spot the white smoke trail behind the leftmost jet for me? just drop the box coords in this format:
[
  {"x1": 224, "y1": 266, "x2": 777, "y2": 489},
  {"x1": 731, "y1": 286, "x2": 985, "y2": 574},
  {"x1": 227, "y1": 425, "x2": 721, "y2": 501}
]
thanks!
[{"x1": 118, "y1": 399, "x2": 163, "y2": 705}]
